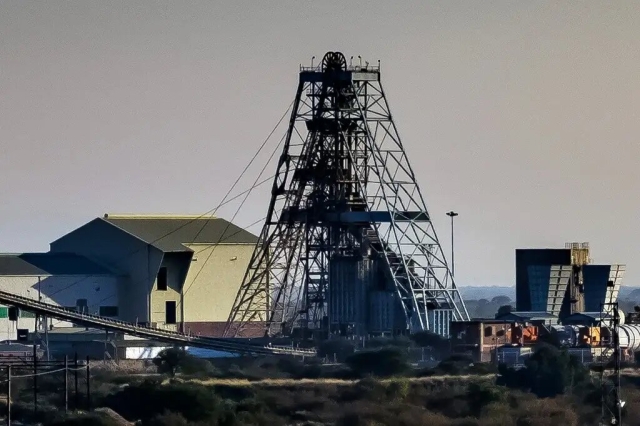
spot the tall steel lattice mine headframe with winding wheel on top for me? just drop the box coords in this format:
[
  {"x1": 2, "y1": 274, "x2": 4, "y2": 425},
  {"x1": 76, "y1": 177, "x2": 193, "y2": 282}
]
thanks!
[{"x1": 225, "y1": 52, "x2": 468, "y2": 336}]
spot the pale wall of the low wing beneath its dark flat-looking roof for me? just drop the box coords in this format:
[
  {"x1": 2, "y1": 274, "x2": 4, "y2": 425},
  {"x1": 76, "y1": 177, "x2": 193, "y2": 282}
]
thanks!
[{"x1": 0, "y1": 275, "x2": 119, "y2": 340}]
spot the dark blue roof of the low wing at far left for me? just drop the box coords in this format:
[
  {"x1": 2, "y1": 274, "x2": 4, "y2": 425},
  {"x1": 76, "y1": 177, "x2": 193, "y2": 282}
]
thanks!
[{"x1": 0, "y1": 253, "x2": 112, "y2": 276}]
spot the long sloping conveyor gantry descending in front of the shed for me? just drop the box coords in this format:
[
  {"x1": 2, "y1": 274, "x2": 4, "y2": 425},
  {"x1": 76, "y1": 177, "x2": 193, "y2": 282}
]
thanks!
[{"x1": 0, "y1": 291, "x2": 316, "y2": 356}]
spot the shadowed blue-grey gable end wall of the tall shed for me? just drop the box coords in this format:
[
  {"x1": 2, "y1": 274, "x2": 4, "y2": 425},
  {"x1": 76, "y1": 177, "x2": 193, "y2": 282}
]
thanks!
[{"x1": 51, "y1": 219, "x2": 162, "y2": 322}]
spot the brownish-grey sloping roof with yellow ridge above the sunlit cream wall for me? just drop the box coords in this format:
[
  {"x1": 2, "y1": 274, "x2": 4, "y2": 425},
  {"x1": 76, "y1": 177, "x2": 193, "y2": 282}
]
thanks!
[{"x1": 103, "y1": 214, "x2": 258, "y2": 252}]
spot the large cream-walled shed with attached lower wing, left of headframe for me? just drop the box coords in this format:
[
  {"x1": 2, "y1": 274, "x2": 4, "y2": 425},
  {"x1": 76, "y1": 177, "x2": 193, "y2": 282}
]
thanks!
[{"x1": 0, "y1": 214, "x2": 257, "y2": 340}]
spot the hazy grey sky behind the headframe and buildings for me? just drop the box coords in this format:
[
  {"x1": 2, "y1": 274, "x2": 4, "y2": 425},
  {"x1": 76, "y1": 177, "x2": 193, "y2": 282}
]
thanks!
[{"x1": 0, "y1": 0, "x2": 640, "y2": 285}]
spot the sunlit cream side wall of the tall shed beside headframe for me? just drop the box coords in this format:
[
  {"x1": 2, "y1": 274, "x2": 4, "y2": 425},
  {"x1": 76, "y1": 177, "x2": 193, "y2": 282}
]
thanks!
[{"x1": 183, "y1": 244, "x2": 255, "y2": 322}]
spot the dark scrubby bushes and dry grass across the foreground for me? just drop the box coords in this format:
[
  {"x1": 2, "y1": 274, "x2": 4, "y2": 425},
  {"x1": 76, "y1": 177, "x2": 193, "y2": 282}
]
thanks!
[{"x1": 5, "y1": 345, "x2": 640, "y2": 426}]
